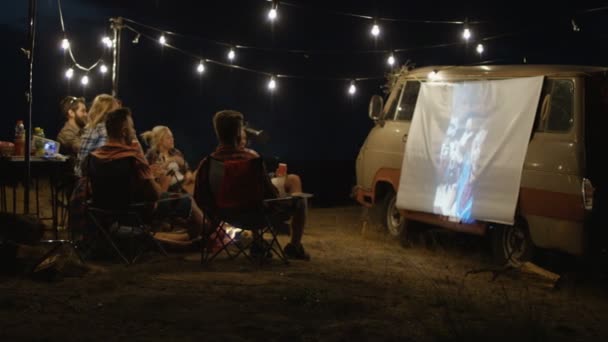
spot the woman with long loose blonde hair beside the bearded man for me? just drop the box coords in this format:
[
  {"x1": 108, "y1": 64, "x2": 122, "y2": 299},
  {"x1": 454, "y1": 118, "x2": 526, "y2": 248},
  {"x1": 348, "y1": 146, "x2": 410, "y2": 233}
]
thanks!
[{"x1": 74, "y1": 94, "x2": 120, "y2": 176}]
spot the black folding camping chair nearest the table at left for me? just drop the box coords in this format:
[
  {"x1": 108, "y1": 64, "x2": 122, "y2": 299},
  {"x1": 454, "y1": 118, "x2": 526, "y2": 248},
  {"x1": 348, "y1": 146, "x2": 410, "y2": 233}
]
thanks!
[{"x1": 86, "y1": 155, "x2": 167, "y2": 265}]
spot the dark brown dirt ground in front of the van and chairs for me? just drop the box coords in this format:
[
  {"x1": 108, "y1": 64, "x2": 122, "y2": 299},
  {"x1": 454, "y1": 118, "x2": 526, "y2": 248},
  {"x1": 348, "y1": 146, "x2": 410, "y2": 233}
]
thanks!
[{"x1": 0, "y1": 202, "x2": 608, "y2": 341}]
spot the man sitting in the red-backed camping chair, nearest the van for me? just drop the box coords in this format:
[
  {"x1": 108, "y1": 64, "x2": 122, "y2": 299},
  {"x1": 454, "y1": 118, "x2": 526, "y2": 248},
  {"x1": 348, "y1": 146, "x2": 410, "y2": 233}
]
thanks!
[{"x1": 194, "y1": 110, "x2": 310, "y2": 260}]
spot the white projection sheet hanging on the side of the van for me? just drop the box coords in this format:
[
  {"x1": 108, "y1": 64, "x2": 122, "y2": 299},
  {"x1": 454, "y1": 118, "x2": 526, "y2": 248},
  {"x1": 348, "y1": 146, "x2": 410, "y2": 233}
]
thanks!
[{"x1": 397, "y1": 76, "x2": 543, "y2": 224}]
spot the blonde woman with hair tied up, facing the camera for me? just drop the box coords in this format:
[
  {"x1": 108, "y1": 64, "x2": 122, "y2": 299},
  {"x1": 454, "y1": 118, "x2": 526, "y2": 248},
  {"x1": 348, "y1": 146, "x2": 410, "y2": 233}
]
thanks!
[{"x1": 141, "y1": 126, "x2": 194, "y2": 193}]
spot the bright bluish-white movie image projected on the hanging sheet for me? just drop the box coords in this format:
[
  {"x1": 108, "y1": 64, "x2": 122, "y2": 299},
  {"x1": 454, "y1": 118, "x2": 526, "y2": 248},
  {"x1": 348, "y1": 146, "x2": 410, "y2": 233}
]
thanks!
[{"x1": 433, "y1": 112, "x2": 487, "y2": 223}]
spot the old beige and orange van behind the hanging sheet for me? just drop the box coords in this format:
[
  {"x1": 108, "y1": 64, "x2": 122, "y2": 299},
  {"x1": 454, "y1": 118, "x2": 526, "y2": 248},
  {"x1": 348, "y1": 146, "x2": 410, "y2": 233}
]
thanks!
[{"x1": 352, "y1": 65, "x2": 608, "y2": 264}]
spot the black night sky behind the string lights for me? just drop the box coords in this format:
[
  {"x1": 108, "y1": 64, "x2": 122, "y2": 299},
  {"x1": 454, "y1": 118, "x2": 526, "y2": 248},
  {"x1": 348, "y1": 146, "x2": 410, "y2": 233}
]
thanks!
[{"x1": 0, "y1": 0, "x2": 608, "y2": 205}]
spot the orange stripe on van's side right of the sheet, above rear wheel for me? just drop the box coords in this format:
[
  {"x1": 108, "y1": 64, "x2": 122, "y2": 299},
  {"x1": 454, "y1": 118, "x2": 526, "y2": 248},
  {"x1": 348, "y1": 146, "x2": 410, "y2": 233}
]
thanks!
[{"x1": 519, "y1": 188, "x2": 585, "y2": 221}]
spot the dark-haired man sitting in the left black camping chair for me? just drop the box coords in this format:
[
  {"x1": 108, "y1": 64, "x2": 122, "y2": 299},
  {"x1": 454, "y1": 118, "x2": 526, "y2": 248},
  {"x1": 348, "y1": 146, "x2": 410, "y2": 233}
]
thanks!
[{"x1": 83, "y1": 107, "x2": 208, "y2": 244}]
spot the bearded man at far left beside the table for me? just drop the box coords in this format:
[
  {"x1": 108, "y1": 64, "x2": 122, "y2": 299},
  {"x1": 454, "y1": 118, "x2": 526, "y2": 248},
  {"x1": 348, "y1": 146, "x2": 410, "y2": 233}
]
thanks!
[{"x1": 57, "y1": 96, "x2": 87, "y2": 157}]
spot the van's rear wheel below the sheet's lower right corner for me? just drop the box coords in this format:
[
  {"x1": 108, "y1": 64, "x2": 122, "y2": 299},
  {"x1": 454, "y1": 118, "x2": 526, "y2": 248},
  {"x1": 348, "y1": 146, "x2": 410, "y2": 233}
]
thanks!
[{"x1": 491, "y1": 218, "x2": 534, "y2": 266}]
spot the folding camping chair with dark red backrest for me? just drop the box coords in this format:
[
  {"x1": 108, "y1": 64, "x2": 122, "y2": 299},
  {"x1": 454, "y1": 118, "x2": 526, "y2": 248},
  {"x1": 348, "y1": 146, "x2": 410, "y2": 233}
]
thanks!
[{"x1": 195, "y1": 156, "x2": 296, "y2": 264}]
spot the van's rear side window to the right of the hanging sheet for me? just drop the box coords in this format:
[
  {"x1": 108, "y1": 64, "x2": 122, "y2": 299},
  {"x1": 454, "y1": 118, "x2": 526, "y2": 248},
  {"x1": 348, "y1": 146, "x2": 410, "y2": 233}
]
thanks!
[{"x1": 536, "y1": 79, "x2": 574, "y2": 133}]
